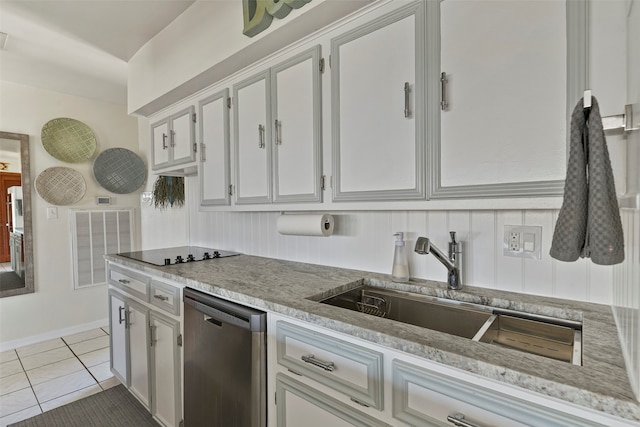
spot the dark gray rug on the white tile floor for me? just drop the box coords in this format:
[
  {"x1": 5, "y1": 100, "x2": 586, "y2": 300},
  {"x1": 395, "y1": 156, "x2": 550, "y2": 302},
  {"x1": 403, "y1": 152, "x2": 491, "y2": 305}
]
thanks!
[{"x1": 9, "y1": 385, "x2": 159, "y2": 427}]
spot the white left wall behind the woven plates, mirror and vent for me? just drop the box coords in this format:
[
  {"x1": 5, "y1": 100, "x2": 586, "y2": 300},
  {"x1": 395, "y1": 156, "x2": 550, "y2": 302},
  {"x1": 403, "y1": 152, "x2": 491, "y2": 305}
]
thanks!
[{"x1": 0, "y1": 81, "x2": 139, "y2": 348}]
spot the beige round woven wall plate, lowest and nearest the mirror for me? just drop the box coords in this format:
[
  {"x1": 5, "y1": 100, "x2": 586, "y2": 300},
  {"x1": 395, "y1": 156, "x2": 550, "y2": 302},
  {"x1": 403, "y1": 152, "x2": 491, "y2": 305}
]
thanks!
[{"x1": 36, "y1": 166, "x2": 87, "y2": 206}]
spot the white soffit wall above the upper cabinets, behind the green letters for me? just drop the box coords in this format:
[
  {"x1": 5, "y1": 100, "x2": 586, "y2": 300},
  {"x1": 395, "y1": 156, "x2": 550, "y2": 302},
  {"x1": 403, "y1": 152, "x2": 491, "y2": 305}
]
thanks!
[{"x1": 128, "y1": 0, "x2": 372, "y2": 116}]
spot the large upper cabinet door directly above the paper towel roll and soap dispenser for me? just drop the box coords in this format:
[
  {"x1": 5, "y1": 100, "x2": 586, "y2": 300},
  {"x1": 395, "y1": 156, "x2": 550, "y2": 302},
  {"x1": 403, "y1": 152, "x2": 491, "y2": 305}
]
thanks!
[{"x1": 331, "y1": 2, "x2": 425, "y2": 201}]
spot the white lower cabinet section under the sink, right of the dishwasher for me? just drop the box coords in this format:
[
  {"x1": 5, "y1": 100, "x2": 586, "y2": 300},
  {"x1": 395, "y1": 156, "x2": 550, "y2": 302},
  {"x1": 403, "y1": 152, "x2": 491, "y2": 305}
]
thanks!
[{"x1": 268, "y1": 313, "x2": 635, "y2": 427}]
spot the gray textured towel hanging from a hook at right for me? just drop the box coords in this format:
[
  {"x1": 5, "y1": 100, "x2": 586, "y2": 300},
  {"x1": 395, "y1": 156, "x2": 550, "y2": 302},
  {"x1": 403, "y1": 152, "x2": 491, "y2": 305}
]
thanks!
[{"x1": 549, "y1": 97, "x2": 624, "y2": 265}]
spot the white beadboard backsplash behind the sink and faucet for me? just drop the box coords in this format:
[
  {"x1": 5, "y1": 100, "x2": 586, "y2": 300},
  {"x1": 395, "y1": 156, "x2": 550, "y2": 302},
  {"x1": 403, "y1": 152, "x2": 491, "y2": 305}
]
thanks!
[{"x1": 189, "y1": 209, "x2": 613, "y2": 304}]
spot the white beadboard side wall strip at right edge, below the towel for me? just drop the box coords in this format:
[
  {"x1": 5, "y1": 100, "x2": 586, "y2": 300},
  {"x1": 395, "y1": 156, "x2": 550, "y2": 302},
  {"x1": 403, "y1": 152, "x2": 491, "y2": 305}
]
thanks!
[{"x1": 613, "y1": 209, "x2": 640, "y2": 402}]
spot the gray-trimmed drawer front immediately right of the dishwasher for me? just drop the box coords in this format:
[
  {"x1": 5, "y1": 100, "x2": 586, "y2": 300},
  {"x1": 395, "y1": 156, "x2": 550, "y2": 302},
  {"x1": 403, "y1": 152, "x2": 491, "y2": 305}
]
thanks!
[{"x1": 276, "y1": 321, "x2": 383, "y2": 410}]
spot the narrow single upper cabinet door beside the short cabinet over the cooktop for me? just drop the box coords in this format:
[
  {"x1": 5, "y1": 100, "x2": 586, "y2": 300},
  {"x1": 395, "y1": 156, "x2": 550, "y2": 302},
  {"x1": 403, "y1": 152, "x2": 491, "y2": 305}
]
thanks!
[{"x1": 199, "y1": 89, "x2": 231, "y2": 206}]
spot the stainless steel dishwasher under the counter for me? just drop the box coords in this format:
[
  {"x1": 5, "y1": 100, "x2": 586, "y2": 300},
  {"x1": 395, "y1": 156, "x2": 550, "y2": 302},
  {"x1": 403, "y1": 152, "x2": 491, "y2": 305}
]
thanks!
[{"x1": 184, "y1": 288, "x2": 267, "y2": 427}]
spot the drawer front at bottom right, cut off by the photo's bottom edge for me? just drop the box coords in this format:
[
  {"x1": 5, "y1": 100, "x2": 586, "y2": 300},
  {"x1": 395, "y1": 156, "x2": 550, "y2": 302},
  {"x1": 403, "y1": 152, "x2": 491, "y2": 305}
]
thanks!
[{"x1": 392, "y1": 360, "x2": 601, "y2": 427}]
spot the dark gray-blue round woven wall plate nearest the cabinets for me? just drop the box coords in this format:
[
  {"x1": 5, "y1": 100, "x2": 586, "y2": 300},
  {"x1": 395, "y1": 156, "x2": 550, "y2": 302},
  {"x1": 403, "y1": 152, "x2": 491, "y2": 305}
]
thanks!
[{"x1": 93, "y1": 148, "x2": 147, "y2": 194}]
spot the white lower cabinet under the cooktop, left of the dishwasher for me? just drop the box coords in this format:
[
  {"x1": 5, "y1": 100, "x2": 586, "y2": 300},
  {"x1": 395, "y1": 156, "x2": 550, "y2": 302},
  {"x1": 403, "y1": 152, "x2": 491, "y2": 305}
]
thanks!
[{"x1": 109, "y1": 264, "x2": 182, "y2": 427}]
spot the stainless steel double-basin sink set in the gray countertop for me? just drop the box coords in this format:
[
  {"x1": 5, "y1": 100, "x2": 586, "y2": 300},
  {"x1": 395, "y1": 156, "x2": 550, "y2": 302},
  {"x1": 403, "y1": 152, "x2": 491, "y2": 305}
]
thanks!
[{"x1": 320, "y1": 285, "x2": 582, "y2": 365}]
